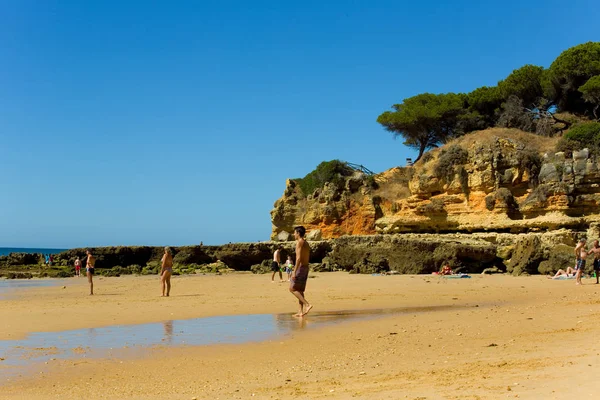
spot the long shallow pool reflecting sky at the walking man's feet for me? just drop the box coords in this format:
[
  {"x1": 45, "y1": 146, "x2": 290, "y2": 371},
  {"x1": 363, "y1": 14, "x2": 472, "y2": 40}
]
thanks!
[{"x1": 0, "y1": 306, "x2": 457, "y2": 366}]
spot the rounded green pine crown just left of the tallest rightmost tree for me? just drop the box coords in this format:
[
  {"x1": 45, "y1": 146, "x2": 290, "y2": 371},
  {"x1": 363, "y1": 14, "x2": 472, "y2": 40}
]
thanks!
[{"x1": 498, "y1": 65, "x2": 544, "y2": 108}]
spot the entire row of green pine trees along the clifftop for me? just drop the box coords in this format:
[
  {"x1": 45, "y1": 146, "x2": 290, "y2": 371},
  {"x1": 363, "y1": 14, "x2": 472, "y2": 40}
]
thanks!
[{"x1": 377, "y1": 42, "x2": 600, "y2": 156}]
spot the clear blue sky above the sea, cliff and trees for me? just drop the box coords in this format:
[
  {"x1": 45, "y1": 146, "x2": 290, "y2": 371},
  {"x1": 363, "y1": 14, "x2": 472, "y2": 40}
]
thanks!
[{"x1": 0, "y1": 0, "x2": 600, "y2": 247}]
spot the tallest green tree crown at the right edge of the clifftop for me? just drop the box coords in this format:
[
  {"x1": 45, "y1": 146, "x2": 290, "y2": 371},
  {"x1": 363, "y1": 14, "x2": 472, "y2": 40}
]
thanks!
[{"x1": 543, "y1": 42, "x2": 600, "y2": 114}]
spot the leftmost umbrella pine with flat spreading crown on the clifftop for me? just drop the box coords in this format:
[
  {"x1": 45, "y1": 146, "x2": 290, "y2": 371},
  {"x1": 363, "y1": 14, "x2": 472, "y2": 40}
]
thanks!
[{"x1": 377, "y1": 93, "x2": 467, "y2": 162}]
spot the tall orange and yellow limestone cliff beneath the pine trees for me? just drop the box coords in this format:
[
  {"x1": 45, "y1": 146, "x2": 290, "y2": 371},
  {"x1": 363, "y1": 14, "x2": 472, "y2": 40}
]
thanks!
[{"x1": 271, "y1": 129, "x2": 600, "y2": 240}]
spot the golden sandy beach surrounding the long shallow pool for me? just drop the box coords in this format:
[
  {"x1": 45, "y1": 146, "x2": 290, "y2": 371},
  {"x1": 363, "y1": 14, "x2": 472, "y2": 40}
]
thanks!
[{"x1": 0, "y1": 273, "x2": 600, "y2": 400}]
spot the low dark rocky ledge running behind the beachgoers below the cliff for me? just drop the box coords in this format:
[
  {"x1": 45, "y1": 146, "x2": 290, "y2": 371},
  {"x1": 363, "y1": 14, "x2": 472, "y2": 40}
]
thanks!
[{"x1": 0, "y1": 229, "x2": 585, "y2": 278}]
